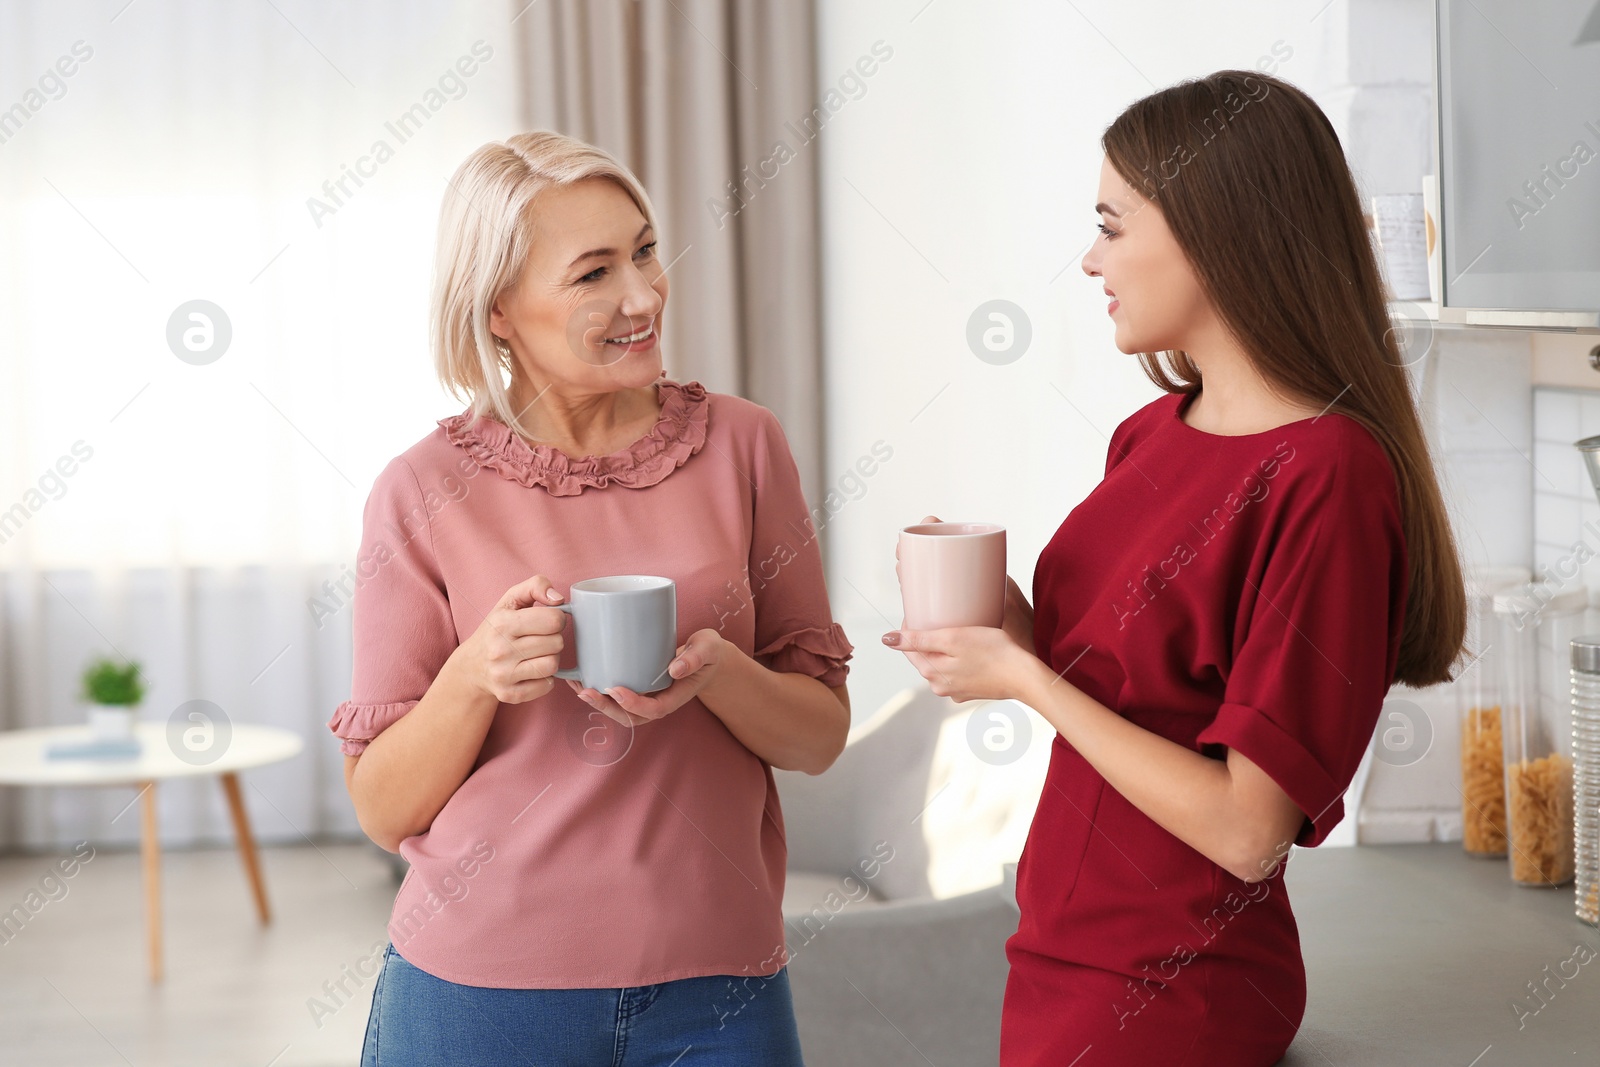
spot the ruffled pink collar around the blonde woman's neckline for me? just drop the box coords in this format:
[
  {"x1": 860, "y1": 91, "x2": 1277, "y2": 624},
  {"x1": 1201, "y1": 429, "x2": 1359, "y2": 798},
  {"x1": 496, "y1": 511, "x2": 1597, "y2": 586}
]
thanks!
[{"x1": 438, "y1": 378, "x2": 710, "y2": 496}]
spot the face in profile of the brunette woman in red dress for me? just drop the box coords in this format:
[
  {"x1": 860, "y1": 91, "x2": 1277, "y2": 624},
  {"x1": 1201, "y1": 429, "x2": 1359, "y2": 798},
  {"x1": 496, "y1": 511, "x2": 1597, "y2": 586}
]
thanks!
[{"x1": 1083, "y1": 160, "x2": 1214, "y2": 355}]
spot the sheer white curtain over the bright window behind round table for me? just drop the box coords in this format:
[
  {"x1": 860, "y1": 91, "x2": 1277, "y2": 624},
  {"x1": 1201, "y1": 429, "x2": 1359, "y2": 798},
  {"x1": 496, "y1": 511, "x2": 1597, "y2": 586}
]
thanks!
[{"x1": 0, "y1": 0, "x2": 518, "y2": 848}]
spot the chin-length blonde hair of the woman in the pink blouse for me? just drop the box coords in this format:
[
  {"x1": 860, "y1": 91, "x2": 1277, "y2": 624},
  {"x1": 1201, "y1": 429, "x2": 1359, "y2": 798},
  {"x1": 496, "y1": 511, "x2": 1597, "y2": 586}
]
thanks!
[{"x1": 429, "y1": 130, "x2": 656, "y2": 427}]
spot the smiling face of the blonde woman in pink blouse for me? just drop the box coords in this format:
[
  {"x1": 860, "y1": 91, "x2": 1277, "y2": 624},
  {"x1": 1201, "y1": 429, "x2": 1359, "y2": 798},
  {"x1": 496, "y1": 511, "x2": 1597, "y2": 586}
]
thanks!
[{"x1": 490, "y1": 178, "x2": 667, "y2": 392}]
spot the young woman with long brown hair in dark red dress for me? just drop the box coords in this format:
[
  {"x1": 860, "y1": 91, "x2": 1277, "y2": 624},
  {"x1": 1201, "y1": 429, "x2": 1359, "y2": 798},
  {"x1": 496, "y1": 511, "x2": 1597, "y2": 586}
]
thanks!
[{"x1": 885, "y1": 70, "x2": 1466, "y2": 1067}]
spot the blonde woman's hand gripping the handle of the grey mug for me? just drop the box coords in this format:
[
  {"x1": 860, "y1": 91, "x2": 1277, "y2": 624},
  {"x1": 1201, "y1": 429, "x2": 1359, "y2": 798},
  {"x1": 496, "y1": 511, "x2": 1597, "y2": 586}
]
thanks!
[{"x1": 456, "y1": 574, "x2": 566, "y2": 704}]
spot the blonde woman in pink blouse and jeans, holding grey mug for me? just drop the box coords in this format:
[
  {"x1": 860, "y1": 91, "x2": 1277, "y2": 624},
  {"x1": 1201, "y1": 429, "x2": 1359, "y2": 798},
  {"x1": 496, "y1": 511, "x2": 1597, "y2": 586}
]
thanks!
[{"x1": 328, "y1": 133, "x2": 851, "y2": 1067}]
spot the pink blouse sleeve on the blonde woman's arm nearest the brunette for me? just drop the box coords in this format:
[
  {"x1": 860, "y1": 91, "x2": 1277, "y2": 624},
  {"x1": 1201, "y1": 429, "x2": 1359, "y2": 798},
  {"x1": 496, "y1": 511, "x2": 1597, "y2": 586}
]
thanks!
[{"x1": 749, "y1": 408, "x2": 854, "y2": 686}]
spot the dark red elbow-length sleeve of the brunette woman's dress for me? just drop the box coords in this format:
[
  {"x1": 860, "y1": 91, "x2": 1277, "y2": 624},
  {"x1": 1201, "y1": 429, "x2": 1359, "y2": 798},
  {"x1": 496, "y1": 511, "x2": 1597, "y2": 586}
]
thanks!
[{"x1": 1197, "y1": 430, "x2": 1408, "y2": 848}]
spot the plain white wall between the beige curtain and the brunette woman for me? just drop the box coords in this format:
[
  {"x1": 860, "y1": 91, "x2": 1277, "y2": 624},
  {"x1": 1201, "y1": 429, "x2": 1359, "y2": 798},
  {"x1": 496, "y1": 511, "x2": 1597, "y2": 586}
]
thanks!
[{"x1": 819, "y1": 0, "x2": 1369, "y2": 717}]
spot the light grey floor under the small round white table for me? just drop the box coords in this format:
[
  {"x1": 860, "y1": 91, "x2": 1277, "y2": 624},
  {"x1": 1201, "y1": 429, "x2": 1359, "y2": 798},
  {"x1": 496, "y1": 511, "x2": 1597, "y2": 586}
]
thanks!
[{"x1": 0, "y1": 845, "x2": 395, "y2": 1067}]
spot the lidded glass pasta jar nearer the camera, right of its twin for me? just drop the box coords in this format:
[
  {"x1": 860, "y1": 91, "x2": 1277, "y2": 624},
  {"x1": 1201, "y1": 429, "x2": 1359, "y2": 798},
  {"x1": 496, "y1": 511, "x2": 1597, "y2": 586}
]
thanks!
[{"x1": 1494, "y1": 582, "x2": 1589, "y2": 886}]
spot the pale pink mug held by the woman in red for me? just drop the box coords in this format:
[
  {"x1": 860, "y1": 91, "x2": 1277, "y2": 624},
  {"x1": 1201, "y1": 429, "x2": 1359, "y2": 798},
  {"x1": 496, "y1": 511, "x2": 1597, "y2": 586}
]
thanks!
[{"x1": 899, "y1": 523, "x2": 1006, "y2": 630}]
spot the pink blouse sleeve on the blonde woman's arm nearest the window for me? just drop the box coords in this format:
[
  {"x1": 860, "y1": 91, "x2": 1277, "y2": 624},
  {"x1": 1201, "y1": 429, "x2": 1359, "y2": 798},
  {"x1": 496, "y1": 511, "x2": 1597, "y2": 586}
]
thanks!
[{"x1": 328, "y1": 459, "x2": 459, "y2": 755}]
